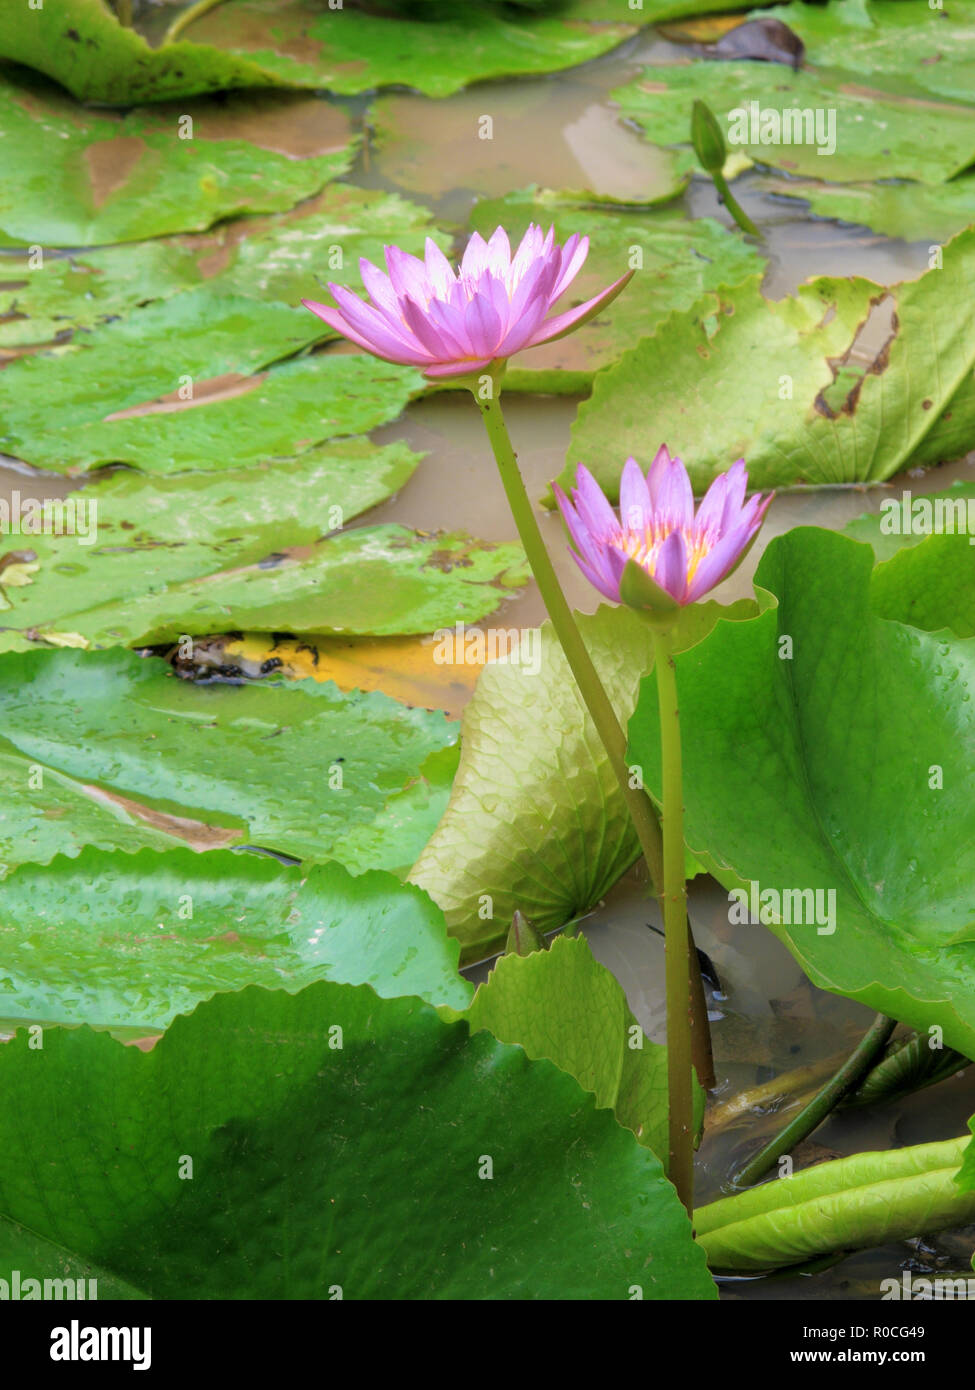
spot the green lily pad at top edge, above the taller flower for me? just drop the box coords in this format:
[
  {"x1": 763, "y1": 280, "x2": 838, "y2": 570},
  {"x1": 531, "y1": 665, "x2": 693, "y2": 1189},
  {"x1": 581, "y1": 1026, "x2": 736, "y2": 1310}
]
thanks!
[{"x1": 184, "y1": 0, "x2": 643, "y2": 96}]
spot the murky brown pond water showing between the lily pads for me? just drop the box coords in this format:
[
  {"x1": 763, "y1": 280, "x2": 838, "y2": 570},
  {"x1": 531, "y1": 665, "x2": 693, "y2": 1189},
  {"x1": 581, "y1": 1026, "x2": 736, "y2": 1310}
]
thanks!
[{"x1": 9, "y1": 6, "x2": 975, "y2": 1300}]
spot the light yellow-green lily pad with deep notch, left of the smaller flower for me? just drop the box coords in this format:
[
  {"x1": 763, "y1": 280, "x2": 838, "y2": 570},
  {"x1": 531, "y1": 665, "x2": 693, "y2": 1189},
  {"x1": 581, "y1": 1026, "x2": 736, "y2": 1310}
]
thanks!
[{"x1": 0, "y1": 439, "x2": 527, "y2": 651}]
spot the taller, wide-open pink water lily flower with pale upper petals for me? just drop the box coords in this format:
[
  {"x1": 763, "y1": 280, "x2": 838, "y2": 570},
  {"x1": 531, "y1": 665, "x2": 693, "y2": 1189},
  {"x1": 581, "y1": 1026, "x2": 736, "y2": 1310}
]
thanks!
[{"x1": 302, "y1": 224, "x2": 633, "y2": 378}]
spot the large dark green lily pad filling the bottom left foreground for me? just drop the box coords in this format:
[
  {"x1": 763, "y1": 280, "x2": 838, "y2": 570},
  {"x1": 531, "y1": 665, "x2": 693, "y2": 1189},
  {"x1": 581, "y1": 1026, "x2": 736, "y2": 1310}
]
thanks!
[{"x1": 0, "y1": 983, "x2": 716, "y2": 1300}]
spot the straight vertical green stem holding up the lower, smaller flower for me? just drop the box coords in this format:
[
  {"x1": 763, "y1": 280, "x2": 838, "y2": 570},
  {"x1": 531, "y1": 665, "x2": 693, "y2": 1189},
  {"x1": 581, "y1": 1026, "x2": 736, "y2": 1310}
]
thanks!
[{"x1": 652, "y1": 626, "x2": 694, "y2": 1213}]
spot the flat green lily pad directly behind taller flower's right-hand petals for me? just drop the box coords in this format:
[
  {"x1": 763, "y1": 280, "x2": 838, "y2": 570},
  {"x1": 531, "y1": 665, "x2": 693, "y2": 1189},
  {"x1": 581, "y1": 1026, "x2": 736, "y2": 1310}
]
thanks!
[{"x1": 472, "y1": 189, "x2": 764, "y2": 392}]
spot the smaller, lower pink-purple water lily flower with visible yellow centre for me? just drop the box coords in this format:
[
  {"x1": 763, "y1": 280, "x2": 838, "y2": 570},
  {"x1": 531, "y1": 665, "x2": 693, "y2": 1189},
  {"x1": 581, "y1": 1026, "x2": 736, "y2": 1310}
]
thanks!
[{"x1": 555, "y1": 445, "x2": 772, "y2": 606}]
